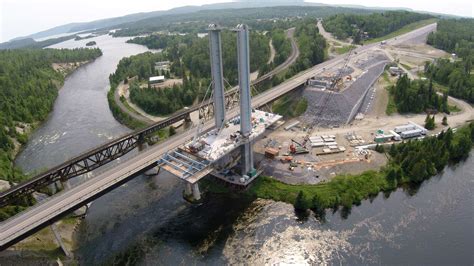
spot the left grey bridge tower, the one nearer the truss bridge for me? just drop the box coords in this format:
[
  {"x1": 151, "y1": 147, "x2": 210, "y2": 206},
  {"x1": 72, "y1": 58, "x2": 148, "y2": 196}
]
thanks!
[{"x1": 208, "y1": 24, "x2": 225, "y2": 128}]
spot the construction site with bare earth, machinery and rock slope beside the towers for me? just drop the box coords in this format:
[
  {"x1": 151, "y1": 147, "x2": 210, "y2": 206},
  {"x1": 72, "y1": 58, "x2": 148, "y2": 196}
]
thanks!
[{"x1": 248, "y1": 29, "x2": 471, "y2": 184}]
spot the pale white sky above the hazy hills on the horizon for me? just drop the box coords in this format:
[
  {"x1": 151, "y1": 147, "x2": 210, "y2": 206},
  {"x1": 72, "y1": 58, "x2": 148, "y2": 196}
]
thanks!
[{"x1": 0, "y1": 0, "x2": 474, "y2": 42}]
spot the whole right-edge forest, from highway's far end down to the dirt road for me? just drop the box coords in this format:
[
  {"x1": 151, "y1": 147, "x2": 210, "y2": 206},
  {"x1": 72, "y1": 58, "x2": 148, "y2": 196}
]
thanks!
[{"x1": 425, "y1": 19, "x2": 474, "y2": 104}]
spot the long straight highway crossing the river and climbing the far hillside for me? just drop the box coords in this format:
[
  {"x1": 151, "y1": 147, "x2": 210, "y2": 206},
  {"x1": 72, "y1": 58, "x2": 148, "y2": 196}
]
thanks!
[{"x1": 0, "y1": 24, "x2": 436, "y2": 250}]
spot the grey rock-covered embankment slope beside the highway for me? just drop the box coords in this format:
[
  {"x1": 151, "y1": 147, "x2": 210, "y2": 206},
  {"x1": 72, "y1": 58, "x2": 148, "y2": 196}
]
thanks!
[{"x1": 301, "y1": 60, "x2": 386, "y2": 127}]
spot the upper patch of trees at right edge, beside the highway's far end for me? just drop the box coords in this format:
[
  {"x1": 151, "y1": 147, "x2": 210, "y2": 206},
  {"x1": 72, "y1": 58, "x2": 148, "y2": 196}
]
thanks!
[{"x1": 427, "y1": 19, "x2": 474, "y2": 58}]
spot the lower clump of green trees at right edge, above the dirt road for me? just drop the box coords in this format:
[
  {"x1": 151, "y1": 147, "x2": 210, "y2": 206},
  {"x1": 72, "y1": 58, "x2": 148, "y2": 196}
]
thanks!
[{"x1": 425, "y1": 57, "x2": 474, "y2": 104}]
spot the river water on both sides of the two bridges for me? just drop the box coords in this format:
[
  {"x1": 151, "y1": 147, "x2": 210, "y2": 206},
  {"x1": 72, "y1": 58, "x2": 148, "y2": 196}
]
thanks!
[{"x1": 12, "y1": 36, "x2": 474, "y2": 265}]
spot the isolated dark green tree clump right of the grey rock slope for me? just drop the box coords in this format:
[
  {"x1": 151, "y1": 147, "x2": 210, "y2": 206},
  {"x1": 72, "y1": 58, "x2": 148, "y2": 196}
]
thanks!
[{"x1": 390, "y1": 74, "x2": 449, "y2": 113}]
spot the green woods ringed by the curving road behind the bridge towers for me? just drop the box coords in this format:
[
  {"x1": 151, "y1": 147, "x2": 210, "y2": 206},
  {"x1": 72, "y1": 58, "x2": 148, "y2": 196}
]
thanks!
[{"x1": 115, "y1": 31, "x2": 270, "y2": 115}]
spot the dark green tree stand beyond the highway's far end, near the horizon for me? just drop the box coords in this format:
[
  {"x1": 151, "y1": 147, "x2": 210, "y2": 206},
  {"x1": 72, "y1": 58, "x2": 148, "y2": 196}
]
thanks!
[{"x1": 323, "y1": 11, "x2": 433, "y2": 43}]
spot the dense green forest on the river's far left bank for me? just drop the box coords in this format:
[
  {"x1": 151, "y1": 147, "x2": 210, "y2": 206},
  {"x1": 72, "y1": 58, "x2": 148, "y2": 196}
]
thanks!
[{"x1": 0, "y1": 49, "x2": 102, "y2": 220}]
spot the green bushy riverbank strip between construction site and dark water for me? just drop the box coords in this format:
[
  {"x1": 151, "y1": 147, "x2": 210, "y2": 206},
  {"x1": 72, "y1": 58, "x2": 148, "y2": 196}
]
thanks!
[{"x1": 247, "y1": 123, "x2": 474, "y2": 214}]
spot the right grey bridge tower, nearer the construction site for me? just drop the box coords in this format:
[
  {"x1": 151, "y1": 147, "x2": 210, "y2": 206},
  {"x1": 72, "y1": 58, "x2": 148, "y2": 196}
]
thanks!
[{"x1": 235, "y1": 24, "x2": 254, "y2": 175}]
